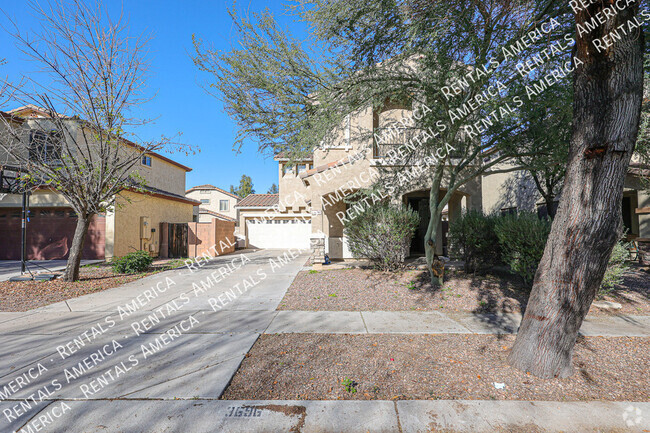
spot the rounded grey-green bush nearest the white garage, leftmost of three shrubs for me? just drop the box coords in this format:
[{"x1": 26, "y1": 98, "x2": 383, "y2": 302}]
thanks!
[{"x1": 345, "y1": 204, "x2": 420, "y2": 270}]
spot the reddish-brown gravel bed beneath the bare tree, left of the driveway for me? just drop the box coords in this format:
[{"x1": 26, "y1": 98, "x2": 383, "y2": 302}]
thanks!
[{"x1": 0, "y1": 263, "x2": 175, "y2": 311}]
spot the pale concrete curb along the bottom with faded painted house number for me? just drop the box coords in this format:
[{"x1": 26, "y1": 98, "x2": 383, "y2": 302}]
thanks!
[{"x1": 0, "y1": 399, "x2": 650, "y2": 433}]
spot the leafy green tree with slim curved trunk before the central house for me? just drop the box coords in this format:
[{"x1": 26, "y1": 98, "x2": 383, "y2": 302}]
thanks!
[{"x1": 194, "y1": 0, "x2": 570, "y2": 284}]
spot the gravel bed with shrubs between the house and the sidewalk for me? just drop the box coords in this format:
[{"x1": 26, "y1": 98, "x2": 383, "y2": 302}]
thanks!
[{"x1": 278, "y1": 268, "x2": 650, "y2": 314}]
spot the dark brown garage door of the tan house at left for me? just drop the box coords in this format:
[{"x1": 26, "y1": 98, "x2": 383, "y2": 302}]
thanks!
[{"x1": 0, "y1": 208, "x2": 106, "y2": 260}]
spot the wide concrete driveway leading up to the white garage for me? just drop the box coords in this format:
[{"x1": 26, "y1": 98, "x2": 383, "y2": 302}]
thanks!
[{"x1": 0, "y1": 250, "x2": 308, "y2": 432}]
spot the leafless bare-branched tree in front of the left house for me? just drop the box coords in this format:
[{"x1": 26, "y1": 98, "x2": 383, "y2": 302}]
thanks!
[{"x1": 0, "y1": 0, "x2": 189, "y2": 281}]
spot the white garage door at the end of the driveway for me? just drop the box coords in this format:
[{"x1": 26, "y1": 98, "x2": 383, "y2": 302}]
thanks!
[{"x1": 246, "y1": 219, "x2": 311, "y2": 249}]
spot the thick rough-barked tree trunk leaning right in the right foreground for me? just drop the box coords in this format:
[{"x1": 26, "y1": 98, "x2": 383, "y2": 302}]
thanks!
[{"x1": 509, "y1": 2, "x2": 644, "y2": 378}]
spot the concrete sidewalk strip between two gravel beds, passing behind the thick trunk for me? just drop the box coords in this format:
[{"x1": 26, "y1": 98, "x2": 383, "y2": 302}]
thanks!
[{"x1": 266, "y1": 310, "x2": 650, "y2": 337}]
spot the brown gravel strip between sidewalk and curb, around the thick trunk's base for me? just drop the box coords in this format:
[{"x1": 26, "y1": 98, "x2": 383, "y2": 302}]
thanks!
[{"x1": 222, "y1": 334, "x2": 650, "y2": 401}]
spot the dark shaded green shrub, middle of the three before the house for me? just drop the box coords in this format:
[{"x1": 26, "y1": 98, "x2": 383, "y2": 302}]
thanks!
[{"x1": 449, "y1": 210, "x2": 499, "y2": 272}]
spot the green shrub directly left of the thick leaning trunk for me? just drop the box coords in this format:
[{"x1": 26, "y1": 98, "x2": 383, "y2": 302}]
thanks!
[{"x1": 494, "y1": 212, "x2": 551, "y2": 285}]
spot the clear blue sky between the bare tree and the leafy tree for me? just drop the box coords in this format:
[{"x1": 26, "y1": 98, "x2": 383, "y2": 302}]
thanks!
[{"x1": 0, "y1": 0, "x2": 303, "y2": 193}]
